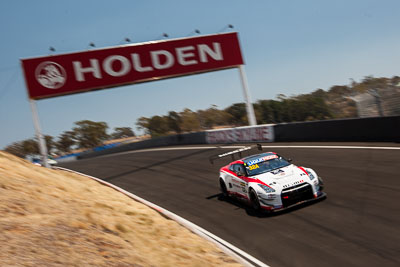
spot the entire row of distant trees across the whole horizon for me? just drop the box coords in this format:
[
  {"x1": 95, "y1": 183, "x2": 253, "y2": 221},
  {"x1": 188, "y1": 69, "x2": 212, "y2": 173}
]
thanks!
[{"x1": 5, "y1": 76, "x2": 400, "y2": 157}]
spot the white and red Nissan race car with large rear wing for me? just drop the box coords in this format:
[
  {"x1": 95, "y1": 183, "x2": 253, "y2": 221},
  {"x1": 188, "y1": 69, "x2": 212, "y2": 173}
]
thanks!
[{"x1": 210, "y1": 145, "x2": 326, "y2": 212}]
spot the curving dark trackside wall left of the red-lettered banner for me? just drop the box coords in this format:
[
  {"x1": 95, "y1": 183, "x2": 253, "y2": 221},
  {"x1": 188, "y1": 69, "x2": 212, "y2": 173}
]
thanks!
[{"x1": 78, "y1": 132, "x2": 206, "y2": 159}]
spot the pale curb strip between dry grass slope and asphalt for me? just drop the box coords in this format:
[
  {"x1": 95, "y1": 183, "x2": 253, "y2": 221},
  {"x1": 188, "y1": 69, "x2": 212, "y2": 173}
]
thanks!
[{"x1": 53, "y1": 167, "x2": 268, "y2": 267}]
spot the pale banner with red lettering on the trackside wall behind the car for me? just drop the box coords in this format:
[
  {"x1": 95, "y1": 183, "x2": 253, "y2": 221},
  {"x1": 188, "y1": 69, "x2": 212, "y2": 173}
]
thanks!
[{"x1": 206, "y1": 124, "x2": 275, "y2": 144}]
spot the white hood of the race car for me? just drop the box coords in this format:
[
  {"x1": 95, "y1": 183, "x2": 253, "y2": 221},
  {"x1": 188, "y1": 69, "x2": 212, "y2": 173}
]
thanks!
[{"x1": 254, "y1": 164, "x2": 308, "y2": 188}]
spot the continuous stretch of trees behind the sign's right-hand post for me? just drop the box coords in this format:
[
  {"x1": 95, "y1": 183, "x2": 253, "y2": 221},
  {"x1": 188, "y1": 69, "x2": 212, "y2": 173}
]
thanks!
[{"x1": 136, "y1": 76, "x2": 400, "y2": 137}]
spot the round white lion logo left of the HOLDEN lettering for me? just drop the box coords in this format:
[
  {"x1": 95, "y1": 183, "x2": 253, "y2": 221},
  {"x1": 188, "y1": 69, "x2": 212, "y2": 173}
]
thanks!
[{"x1": 35, "y1": 61, "x2": 67, "y2": 89}]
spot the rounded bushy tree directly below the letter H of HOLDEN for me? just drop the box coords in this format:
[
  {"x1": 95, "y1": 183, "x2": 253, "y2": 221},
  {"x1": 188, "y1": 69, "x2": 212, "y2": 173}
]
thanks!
[{"x1": 73, "y1": 120, "x2": 109, "y2": 148}]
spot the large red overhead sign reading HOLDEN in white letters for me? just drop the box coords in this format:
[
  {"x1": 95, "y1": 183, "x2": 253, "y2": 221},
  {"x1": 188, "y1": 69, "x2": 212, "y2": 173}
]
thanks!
[{"x1": 21, "y1": 33, "x2": 243, "y2": 99}]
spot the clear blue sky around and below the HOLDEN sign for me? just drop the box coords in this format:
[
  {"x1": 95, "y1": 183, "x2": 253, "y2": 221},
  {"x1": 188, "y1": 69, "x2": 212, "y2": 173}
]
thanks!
[{"x1": 0, "y1": 0, "x2": 400, "y2": 149}]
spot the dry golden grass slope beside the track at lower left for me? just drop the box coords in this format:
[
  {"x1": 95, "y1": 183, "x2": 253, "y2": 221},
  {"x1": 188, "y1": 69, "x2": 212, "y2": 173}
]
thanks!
[{"x1": 0, "y1": 151, "x2": 239, "y2": 267}]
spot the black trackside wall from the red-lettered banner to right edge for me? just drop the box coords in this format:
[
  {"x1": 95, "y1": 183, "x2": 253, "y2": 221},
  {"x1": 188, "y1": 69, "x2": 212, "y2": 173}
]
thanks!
[{"x1": 274, "y1": 116, "x2": 400, "y2": 142}]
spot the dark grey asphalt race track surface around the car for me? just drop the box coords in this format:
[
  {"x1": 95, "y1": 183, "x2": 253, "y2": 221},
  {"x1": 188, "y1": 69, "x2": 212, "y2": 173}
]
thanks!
[{"x1": 62, "y1": 143, "x2": 400, "y2": 266}]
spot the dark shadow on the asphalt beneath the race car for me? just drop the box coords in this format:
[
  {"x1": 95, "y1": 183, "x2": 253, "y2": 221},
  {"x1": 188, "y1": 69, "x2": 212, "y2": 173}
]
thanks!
[{"x1": 206, "y1": 193, "x2": 327, "y2": 218}]
